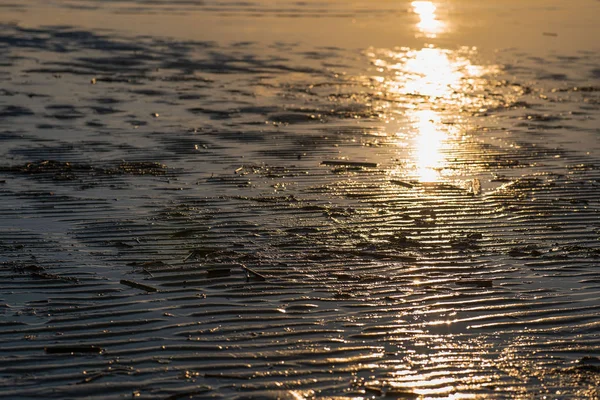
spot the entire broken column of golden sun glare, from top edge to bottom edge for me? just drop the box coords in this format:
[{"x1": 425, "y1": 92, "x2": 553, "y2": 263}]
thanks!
[{"x1": 354, "y1": 1, "x2": 505, "y2": 399}]
